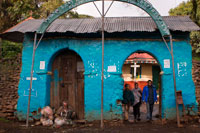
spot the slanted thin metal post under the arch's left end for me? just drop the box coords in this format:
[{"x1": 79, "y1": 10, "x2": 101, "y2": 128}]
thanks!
[{"x1": 26, "y1": 33, "x2": 37, "y2": 127}]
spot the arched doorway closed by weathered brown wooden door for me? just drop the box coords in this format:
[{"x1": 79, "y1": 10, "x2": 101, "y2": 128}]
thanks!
[{"x1": 50, "y1": 50, "x2": 84, "y2": 119}]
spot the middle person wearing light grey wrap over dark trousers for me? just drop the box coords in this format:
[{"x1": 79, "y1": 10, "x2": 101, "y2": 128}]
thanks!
[{"x1": 132, "y1": 83, "x2": 142, "y2": 121}]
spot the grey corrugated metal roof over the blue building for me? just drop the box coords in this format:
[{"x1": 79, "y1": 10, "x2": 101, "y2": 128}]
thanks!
[{"x1": 1, "y1": 16, "x2": 200, "y2": 42}]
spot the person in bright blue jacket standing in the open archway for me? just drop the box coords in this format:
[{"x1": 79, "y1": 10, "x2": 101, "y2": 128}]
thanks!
[{"x1": 142, "y1": 80, "x2": 157, "y2": 120}]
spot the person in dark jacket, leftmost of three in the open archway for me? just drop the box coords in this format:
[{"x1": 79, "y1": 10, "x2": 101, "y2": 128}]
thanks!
[{"x1": 122, "y1": 84, "x2": 134, "y2": 121}]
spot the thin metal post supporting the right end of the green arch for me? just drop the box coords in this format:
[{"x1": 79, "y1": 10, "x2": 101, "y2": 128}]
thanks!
[{"x1": 170, "y1": 35, "x2": 181, "y2": 127}]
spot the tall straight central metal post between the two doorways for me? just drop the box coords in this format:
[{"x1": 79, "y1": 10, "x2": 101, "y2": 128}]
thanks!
[{"x1": 101, "y1": 0, "x2": 105, "y2": 128}]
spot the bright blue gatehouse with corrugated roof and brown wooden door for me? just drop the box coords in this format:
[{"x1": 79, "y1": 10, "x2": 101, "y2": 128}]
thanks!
[{"x1": 1, "y1": 16, "x2": 200, "y2": 120}]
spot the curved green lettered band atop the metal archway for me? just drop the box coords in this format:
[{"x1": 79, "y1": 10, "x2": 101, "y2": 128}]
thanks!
[{"x1": 37, "y1": 0, "x2": 170, "y2": 36}]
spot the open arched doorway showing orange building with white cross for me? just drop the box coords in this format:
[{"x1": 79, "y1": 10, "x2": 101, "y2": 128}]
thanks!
[{"x1": 122, "y1": 51, "x2": 162, "y2": 120}]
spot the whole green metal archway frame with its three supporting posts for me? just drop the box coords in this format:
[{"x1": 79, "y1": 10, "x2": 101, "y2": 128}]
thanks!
[{"x1": 26, "y1": 0, "x2": 180, "y2": 128}]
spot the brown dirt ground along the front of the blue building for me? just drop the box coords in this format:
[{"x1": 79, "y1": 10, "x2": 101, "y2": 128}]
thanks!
[{"x1": 0, "y1": 120, "x2": 200, "y2": 133}]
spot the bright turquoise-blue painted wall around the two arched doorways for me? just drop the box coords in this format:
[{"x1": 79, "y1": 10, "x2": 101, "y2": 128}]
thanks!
[{"x1": 17, "y1": 35, "x2": 196, "y2": 120}]
